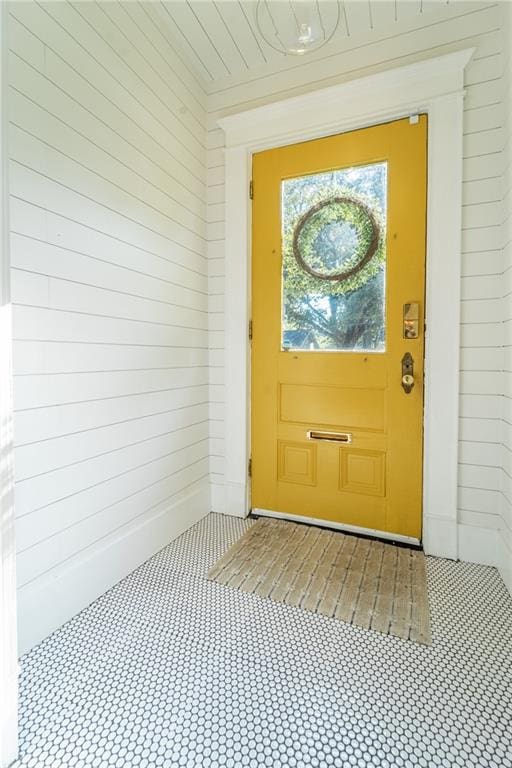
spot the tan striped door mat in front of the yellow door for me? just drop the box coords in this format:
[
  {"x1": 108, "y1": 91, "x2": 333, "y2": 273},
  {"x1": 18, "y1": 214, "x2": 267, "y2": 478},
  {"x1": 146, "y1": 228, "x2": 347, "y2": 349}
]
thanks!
[{"x1": 208, "y1": 518, "x2": 431, "y2": 645}]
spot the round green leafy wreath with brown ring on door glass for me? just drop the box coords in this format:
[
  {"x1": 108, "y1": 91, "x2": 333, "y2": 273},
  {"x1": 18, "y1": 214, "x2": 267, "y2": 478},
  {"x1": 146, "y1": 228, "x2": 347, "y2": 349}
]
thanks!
[{"x1": 292, "y1": 195, "x2": 381, "y2": 283}]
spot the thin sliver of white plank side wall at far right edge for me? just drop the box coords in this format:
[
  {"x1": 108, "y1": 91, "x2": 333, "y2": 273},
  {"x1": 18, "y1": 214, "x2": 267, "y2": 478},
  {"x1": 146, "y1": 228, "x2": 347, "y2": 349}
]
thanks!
[{"x1": 498, "y1": 3, "x2": 512, "y2": 592}]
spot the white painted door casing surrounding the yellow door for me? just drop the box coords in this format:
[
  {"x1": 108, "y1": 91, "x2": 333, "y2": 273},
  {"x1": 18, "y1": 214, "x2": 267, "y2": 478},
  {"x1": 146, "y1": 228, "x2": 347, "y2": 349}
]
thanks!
[{"x1": 218, "y1": 48, "x2": 474, "y2": 559}]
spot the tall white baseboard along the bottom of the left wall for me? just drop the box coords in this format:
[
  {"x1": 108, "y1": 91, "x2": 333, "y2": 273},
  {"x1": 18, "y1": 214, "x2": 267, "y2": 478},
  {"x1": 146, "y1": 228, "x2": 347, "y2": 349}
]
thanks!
[{"x1": 18, "y1": 481, "x2": 209, "y2": 655}]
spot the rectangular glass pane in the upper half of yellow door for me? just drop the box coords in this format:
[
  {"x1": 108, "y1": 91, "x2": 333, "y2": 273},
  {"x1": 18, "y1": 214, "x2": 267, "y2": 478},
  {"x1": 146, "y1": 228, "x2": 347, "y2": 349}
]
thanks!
[{"x1": 281, "y1": 163, "x2": 387, "y2": 352}]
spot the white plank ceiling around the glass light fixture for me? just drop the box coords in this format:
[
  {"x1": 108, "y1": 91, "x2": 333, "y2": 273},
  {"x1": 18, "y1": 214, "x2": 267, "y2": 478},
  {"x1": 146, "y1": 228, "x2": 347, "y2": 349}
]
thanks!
[{"x1": 157, "y1": 0, "x2": 458, "y2": 87}]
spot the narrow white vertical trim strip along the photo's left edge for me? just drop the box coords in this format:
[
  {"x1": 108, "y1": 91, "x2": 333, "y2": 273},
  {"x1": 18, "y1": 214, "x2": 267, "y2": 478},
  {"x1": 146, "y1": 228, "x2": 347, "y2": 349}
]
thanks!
[{"x1": 0, "y1": 3, "x2": 18, "y2": 768}]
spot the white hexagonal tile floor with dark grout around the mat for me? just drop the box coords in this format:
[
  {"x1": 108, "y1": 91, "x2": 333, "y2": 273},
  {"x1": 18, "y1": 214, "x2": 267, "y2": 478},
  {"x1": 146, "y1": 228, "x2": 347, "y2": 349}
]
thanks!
[{"x1": 15, "y1": 515, "x2": 512, "y2": 768}]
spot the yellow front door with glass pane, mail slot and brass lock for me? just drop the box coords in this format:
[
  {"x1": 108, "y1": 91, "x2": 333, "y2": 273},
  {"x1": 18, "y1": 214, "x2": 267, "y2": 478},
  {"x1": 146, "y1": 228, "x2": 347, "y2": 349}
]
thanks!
[{"x1": 251, "y1": 115, "x2": 427, "y2": 539}]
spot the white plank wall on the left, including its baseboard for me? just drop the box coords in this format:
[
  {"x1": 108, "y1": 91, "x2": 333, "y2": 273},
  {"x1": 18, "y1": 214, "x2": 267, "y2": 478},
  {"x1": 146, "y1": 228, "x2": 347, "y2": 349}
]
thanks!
[{"x1": 9, "y1": 2, "x2": 209, "y2": 652}]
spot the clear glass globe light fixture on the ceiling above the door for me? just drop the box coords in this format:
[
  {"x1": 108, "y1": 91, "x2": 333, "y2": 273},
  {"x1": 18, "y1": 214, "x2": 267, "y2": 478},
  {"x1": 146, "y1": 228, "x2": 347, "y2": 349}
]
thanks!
[{"x1": 256, "y1": 0, "x2": 340, "y2": 56}]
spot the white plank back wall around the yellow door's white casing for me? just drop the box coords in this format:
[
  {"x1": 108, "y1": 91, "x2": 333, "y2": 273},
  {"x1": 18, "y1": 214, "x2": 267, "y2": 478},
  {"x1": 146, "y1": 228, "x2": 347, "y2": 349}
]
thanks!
[{"x1": 208, "y1": 3, "x2": 504, "y2": 564}]
